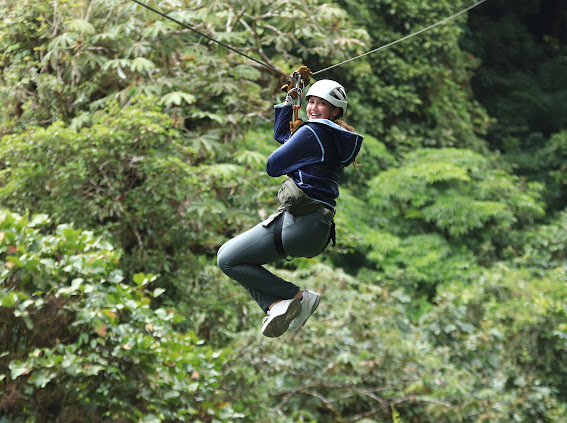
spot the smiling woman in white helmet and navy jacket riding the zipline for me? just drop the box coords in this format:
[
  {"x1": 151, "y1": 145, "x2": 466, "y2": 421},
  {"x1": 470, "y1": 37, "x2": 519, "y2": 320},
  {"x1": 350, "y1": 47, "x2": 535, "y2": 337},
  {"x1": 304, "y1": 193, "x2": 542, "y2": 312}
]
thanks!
[{"x1": 217, "y1": 80, "x2": 362, "y2": 337}]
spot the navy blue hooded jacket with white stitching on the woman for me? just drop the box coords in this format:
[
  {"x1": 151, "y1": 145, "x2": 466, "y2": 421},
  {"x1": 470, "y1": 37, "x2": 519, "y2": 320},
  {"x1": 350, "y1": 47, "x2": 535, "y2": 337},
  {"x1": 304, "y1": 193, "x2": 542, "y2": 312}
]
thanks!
[{"x1": 266, "y1": 103, "x2": 363, "y2": 209}]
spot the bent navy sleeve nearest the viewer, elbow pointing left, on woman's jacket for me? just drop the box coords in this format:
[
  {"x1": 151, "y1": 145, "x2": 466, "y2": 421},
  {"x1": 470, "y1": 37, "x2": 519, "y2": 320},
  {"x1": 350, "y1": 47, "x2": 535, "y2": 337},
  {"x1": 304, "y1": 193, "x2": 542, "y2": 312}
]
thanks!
[{"x1": 266, "y1": 124, "x2": 325, "y2": 176}]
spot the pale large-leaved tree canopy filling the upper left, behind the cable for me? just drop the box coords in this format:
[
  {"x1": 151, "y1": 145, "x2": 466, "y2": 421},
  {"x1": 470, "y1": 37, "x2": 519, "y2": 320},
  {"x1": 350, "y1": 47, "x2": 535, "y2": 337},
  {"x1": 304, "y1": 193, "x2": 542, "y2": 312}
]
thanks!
[{"x1": 0, "y1": 0, "x2": 365, "y2": 142}]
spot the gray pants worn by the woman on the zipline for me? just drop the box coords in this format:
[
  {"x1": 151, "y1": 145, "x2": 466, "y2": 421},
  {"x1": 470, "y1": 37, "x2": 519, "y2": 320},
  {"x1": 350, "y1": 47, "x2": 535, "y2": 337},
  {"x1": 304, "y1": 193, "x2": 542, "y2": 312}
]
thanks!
[{"x1": 217, "y1": 212, "x2": 332, "y2": 312}]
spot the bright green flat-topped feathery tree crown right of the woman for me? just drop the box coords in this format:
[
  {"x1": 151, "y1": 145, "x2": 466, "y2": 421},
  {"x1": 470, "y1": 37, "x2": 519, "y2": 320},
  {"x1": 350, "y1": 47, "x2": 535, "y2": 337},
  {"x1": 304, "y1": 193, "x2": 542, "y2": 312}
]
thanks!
[{"x1": 369, "y1": 149, "x2": 544, "y2": 243}]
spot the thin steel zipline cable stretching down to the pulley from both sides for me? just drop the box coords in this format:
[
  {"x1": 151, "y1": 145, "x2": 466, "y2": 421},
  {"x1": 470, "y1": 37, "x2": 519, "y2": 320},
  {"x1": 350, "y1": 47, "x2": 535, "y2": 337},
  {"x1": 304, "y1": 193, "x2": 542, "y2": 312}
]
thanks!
[{"x1": 132, "y1": 0, "x2": 486, "y2": 80}]
